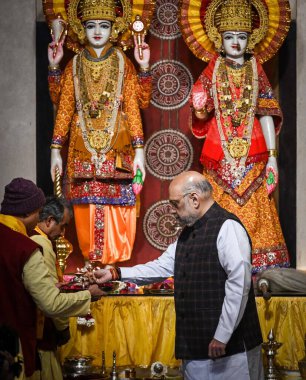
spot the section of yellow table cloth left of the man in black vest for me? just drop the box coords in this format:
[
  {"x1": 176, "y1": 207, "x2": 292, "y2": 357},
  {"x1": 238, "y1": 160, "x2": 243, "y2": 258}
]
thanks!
[{"x1": 61, "y1": 296, "x2": 180, "y2": 367}]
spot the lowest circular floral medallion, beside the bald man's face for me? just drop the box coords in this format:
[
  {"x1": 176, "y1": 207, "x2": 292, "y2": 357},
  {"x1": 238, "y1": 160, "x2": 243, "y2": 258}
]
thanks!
[{"x1": 143, "y1": 201, "x2": 181, "y2": 251}]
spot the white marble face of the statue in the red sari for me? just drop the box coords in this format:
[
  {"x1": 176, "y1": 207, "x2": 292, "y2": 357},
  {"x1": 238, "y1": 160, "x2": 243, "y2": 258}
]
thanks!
[{"x1": 222, "y1": 31, "x2": 248, "y2": 59}]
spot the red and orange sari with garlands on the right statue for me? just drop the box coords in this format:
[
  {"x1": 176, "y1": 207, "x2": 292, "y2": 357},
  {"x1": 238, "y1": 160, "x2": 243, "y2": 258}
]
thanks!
[{"x1": 191, "y1": 55, "x2": 289, "y2": 273}]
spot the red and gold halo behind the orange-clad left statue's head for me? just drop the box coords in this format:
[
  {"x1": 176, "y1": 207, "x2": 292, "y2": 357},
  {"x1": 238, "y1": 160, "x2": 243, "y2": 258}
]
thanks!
[{"x1": 42, "y1": 0, "x2": 155, "y2": 53}]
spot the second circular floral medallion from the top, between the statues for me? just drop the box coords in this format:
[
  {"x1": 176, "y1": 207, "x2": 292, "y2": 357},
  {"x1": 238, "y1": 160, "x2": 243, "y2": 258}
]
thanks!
[{"x1": 151, "y1": 60, "x2": 193, "y2": 111}]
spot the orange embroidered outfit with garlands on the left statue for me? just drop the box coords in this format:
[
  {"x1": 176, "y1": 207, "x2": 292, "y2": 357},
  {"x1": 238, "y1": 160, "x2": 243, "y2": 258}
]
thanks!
[{"x1": 51, "y1": 44, "x2": 151, "y2": 264}]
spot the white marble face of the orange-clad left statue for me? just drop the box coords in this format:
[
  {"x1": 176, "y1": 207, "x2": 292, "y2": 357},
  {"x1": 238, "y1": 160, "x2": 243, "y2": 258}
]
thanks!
[{"x1": 85, "y1": 20, "x2": 112, "y2": 49}]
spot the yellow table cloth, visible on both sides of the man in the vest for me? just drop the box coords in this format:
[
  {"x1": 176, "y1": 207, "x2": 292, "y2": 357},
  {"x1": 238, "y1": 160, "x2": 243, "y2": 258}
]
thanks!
[{"x1": 61, "y1": 296, "x2": 306, "y2": 370}]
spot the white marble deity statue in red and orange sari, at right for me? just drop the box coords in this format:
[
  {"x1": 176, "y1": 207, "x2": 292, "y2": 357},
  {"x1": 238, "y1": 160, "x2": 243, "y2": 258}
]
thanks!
[{"x1": 183, "y1": 0, "x2": 289, "y2": 273}]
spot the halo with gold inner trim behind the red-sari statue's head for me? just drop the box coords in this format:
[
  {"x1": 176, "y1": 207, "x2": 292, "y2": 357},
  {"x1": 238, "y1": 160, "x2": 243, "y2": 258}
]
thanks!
[{"x1": 179, "y1": 0, "x2": 291, "y2": 63}]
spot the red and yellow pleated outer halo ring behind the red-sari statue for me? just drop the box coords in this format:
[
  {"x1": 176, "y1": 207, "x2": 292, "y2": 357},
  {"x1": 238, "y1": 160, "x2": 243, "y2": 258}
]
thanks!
[{"x1": 179, "y1": 0, "x2": 291, "y2": 63}]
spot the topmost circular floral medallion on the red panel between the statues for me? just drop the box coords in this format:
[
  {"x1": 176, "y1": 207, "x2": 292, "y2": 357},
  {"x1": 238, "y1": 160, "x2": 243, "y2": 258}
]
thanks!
[{"x1": 150, "y1": 0, "x2": 181, "y2": 40}]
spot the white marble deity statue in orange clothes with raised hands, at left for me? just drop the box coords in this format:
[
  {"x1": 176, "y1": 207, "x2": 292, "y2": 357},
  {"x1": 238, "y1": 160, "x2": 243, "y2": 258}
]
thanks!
[{"x1": 48, "y1": 0, "x2": 151, "y2": 264}]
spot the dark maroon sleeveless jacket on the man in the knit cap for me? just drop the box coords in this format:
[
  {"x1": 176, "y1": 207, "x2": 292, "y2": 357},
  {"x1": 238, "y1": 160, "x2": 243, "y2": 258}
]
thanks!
[{"x1": 0, "y1": 223, "x2": 40, "y2": 376}]
